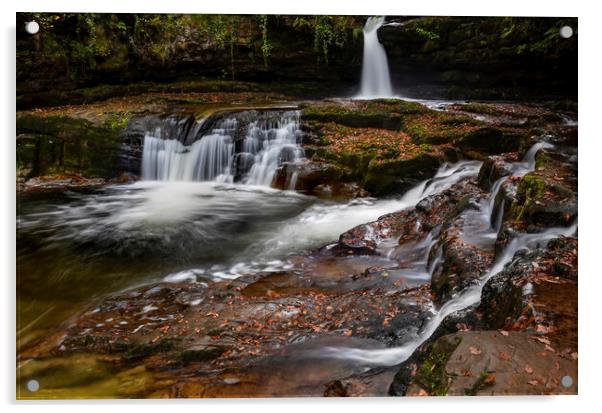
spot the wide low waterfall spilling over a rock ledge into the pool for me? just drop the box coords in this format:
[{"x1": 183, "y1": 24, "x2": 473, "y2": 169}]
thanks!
[{"x1": 142, "y1": 111, "x2": 304, "y2": 189}]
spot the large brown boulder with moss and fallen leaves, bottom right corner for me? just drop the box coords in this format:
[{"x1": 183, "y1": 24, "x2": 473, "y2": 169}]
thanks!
[{"x1": 398, "y1": 331, "x2": 577, "y2": 396}]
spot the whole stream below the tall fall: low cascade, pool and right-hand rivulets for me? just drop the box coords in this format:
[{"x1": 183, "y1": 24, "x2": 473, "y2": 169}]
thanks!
[{"x1": 17, "y1": 101, "x2": 577, "y2": 394}]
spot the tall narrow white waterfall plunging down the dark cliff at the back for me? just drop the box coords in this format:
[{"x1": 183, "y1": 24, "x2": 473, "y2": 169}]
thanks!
[{"x1": 360, "y1": 17, "x2": 393, "y2": 99}]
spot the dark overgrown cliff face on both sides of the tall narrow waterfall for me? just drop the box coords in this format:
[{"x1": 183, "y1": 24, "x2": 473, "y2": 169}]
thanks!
[{"x1": 17, "y1": 13, "x2": 577, "y2": 107}]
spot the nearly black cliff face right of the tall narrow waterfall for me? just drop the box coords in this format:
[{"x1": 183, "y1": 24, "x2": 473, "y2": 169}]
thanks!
[{"x1": 379, "y1": 17, "x2": 577, "y2": 99}]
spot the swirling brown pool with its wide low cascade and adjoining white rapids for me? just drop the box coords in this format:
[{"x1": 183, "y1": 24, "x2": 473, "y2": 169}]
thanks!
[{"x1": 17, "y1": 112, "x2": 480, "y2": 343}]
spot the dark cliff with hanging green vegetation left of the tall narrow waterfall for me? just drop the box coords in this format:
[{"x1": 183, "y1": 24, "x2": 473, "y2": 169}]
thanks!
[{"x1": 17, "y1": 13, "x2": 362, "y2": 99}]
